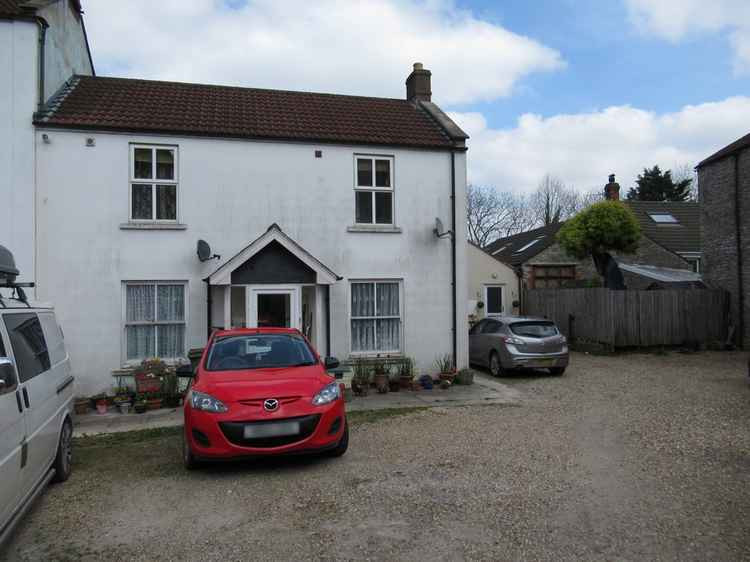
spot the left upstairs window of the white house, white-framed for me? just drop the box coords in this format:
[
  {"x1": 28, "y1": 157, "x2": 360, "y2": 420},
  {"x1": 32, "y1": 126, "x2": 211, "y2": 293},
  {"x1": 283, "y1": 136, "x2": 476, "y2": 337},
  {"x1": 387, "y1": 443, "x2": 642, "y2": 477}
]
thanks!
[{"x1": 130, "y1": 145, "x2": 177, "y2": 222}]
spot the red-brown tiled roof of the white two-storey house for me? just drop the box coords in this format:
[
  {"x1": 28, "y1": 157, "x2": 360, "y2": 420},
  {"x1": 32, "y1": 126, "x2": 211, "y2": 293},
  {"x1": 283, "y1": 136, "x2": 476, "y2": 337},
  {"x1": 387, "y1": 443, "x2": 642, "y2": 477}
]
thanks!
[{"x1": 36, "y1": 76, "x2": 468, "y2": 148}]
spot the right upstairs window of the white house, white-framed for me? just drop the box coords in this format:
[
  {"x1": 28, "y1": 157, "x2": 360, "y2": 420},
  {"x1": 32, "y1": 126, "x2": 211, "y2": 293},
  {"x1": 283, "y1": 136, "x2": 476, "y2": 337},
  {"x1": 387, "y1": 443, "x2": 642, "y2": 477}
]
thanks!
[{"x1": 354, "y1": 156, "x2": 393, "y2": 225}]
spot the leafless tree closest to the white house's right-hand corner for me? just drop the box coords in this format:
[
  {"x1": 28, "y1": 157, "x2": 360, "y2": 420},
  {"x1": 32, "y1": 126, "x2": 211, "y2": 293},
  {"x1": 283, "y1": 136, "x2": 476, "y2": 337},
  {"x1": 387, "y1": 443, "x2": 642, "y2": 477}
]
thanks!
[{"x1": 466, "y1": 185, "x2": 527, "y2": 247}]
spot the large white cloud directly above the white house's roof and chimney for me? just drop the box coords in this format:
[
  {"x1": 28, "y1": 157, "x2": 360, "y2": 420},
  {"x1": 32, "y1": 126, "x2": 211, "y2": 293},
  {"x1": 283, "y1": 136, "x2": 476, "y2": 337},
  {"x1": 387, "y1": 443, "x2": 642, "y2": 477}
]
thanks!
[{"x1": 84, "y1": 0, "x2": 564, "y2": 105}]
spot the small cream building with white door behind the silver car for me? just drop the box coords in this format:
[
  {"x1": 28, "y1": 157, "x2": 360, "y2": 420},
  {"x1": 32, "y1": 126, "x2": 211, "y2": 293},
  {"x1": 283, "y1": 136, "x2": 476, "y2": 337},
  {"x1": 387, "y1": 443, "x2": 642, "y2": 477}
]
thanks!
[{"x1": 466, "y1": 242, "x2": 519, "y2": 322}]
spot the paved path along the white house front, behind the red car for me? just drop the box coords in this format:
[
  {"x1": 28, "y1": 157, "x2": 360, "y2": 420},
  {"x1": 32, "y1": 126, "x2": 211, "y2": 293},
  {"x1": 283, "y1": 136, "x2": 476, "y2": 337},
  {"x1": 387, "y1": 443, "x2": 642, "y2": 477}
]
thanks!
[{"x1": 73, "y1": 373, "x2": 521, "y2": 437}]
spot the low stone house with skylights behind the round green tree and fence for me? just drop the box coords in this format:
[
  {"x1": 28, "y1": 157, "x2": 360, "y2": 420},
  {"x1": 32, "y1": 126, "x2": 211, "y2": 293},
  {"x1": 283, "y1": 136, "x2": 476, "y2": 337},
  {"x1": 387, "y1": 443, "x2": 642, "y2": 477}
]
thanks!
[{"x1": 485, "y1": 174, "x2": 702, "y2": 289}]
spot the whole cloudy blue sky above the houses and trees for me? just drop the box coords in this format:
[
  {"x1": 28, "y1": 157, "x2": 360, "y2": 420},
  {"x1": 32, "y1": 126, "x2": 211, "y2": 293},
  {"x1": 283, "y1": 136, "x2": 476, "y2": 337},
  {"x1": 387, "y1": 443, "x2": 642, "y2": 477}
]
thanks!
[{"x1": 83, "y1": 0, "x2": 750, "y2": 192}]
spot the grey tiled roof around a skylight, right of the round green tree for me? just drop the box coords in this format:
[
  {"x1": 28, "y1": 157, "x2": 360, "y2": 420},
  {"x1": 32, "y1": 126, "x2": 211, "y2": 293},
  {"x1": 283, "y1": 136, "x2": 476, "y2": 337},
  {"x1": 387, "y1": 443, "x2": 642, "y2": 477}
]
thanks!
[{"x1": 626, "y1": 201, "x2": 701, "y2": 253}]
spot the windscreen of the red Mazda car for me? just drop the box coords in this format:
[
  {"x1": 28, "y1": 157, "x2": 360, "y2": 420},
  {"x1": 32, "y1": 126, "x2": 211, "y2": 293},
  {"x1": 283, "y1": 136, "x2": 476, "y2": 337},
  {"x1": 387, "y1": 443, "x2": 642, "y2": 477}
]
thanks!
[{"x1": 206, "y1": 334, "x2": 315, "y2": 371}]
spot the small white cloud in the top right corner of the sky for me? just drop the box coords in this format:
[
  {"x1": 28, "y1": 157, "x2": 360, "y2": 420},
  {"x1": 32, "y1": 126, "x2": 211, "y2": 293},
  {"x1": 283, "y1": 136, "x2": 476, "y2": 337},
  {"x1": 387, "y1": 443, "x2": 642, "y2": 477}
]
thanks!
[{"x1": 625, "y1": 0, "x2": 750, "y2": 74}]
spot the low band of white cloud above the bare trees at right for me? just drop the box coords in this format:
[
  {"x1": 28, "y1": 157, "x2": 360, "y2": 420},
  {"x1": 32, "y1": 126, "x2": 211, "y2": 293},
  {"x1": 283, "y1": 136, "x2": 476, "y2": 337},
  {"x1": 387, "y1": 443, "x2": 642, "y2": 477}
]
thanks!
[{"x1": 450, "y1": 97, "x2": 750, "y2": 192}]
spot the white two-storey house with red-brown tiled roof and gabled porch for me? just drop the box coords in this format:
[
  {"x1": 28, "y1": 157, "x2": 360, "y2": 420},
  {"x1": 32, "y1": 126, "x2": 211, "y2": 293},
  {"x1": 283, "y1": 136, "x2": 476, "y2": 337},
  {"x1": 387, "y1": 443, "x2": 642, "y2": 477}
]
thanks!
[{"x1": 0, "y1": 2, "x2": 468, "y2": 394}]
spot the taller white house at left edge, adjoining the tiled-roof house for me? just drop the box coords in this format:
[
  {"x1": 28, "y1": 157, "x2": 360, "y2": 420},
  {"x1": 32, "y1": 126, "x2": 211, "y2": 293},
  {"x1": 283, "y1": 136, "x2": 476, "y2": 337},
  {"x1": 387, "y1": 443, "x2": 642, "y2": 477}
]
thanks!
[{"x1": 0, "y1": 0, "x2": 94, "y2": 281}]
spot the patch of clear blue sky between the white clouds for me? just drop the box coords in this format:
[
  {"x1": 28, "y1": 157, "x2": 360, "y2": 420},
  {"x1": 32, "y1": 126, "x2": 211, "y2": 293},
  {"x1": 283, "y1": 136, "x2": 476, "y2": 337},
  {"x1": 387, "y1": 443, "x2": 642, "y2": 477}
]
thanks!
[{"x1": 458, "y1": 0, "x2": 750, "y2": 130}]
